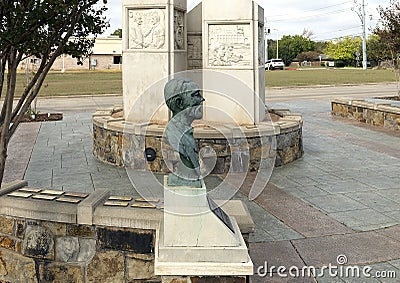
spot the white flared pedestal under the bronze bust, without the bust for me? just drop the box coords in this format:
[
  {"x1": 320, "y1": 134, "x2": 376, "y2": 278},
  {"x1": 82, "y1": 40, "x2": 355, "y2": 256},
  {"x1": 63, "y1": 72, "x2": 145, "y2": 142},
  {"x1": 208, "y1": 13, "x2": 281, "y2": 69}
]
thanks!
[{"x1": 155, "y1": 176, "x2": 253, "y2": 275}]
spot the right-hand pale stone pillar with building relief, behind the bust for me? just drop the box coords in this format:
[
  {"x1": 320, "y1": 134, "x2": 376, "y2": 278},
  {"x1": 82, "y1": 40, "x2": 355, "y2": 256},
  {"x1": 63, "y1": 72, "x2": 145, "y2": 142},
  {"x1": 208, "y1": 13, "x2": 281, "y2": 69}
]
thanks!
[{"x1": 202, "y1": 0, "x2": 265, "y2": 125}]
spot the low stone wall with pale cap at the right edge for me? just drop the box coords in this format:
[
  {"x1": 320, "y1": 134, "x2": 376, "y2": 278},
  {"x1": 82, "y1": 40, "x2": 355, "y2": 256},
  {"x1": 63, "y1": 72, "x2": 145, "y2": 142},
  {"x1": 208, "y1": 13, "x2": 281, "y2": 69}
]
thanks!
[{"x1": 332, "y1": 98, "x2": 400, "y2": 131}]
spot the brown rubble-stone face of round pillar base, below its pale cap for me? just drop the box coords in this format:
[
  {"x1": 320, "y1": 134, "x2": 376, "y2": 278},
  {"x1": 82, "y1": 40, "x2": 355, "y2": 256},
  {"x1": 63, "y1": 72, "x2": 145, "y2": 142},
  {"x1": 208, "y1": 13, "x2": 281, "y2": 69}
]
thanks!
[{"x1": 93, "y1": 123, "x2": 304, "y2": 171}]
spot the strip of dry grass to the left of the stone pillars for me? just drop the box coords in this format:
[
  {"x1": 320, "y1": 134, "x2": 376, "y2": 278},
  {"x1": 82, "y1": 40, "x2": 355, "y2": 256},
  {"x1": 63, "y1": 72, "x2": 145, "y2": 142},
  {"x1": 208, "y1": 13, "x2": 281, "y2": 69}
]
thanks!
[{"x1": 11, "y1": 71, "x2": 122, "y2": 97}]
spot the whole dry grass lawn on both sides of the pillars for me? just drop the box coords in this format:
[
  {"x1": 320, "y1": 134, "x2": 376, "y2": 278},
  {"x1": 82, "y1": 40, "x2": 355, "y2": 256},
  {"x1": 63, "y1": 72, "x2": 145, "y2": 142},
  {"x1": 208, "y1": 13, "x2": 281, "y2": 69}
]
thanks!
[{"x1": 3, "y1": 69, "x2": 395, "y2": 97}]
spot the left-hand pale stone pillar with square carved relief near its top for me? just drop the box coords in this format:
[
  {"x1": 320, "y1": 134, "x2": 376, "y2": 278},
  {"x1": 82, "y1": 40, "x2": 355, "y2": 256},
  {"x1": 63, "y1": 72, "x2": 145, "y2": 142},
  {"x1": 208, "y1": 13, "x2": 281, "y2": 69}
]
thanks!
[{"x1": 122, "y1": 0, "x2": 187, "y2": 123}]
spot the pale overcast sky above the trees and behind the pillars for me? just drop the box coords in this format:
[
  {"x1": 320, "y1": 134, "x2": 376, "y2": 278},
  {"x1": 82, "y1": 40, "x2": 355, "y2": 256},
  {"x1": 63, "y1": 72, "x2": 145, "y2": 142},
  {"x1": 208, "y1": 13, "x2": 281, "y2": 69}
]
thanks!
[{"x1": 104, "y1": 0, "x2": 390, "y2": 41}]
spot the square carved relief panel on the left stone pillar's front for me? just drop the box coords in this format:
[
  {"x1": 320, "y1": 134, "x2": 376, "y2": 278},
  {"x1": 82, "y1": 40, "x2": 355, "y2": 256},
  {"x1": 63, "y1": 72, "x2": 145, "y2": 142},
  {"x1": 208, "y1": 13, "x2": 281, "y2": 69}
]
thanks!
[{"x1": 128, "y1": 9, "x2": 167, "y2": 49}]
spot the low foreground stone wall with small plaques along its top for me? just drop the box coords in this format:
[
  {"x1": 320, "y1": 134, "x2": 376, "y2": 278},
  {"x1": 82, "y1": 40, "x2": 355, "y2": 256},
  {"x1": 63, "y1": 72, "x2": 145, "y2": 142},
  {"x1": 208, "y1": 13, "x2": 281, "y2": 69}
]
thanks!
[{"x1": 0, "y1": 182, "x2": 254, "y2": 283}]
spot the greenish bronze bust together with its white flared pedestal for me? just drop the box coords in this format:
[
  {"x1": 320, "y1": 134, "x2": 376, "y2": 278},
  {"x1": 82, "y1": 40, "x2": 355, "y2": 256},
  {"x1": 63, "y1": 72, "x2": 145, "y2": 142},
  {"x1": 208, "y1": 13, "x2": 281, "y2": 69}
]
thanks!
[{"x1": 155, "y1": 78, "x2": 253, "y2": 276}]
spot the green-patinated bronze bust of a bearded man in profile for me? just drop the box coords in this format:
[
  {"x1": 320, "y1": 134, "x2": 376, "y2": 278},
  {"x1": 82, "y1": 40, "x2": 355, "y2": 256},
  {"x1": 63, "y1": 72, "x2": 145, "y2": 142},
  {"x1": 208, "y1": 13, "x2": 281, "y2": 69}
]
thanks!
[{"x1": 164, "y1": 78, "x2": 204, "y2": 186}]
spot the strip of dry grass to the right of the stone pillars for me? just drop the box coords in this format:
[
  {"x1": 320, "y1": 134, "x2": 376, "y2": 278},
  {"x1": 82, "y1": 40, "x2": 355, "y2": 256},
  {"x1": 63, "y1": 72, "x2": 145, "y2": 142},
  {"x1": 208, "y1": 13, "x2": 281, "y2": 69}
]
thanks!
[{"x1": 265, "y1": 69, "x2": 396, "y2": 87}]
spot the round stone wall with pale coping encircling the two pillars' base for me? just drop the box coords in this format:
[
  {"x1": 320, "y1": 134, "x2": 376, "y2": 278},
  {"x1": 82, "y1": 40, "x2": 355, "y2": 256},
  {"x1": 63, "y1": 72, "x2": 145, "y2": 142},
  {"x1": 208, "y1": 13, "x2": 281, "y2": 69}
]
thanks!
[{"x1": 93, "y1": 109, "x2": 303, "y2": 174}]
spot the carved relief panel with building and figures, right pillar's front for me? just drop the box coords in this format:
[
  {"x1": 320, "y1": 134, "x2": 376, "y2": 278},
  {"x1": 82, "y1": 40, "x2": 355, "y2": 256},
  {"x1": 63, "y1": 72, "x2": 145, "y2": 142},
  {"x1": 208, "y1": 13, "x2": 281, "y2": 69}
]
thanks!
[{"x1": 208, "y1": 24, "x2": 252, "y2": 67}]
